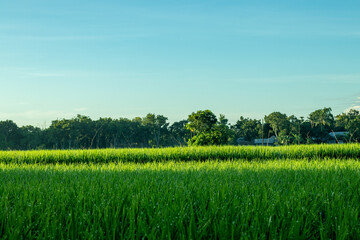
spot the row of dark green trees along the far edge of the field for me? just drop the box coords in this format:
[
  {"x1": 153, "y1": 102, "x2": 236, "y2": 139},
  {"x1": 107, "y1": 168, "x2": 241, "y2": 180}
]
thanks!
[{"x1": 0, "y1": 108, "x2": 360, "y2": 150}]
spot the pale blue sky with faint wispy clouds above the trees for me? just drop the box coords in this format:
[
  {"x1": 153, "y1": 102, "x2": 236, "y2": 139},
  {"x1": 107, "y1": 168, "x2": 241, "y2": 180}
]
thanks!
[{"x1": 0, "y1": 0, "x2": 360, "y2": 127}]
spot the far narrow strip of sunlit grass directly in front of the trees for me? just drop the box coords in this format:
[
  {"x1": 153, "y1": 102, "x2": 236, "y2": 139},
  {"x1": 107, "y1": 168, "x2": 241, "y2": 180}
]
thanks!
[{"x1": 0, "y1": 144, "x2": 360, "y2": 163}]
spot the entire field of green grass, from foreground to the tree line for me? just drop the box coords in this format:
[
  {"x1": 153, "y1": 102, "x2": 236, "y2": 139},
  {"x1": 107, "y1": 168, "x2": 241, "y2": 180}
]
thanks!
[{"x1": 0, "y1": 144, "x2": 360, "y2": 239}]
